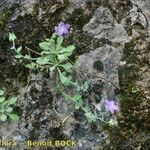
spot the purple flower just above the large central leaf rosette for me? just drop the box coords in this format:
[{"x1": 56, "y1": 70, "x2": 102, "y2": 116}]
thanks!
[{"x1": 55, "y1": 22, "x2": 70, "y2": 36}]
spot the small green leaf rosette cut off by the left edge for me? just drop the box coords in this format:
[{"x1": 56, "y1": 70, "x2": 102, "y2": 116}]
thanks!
[{"x1": 0, "y1": 90, "x2": 19, "y2": 122}]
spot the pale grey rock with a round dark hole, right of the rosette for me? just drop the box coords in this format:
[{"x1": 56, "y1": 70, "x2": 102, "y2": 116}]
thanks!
[{"x1": 76, "y1": 45, "x2": 122, "y2": 100}]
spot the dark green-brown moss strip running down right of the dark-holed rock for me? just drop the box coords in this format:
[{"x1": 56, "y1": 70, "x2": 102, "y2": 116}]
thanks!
[{"x1": 104, "y1": 37, "x2": 149, "y2": 150}]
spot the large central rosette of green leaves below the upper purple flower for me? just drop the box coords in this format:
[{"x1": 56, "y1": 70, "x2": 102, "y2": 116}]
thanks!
[{"x1": 36, "y1": 33, "x2": 75, "y2": 73}]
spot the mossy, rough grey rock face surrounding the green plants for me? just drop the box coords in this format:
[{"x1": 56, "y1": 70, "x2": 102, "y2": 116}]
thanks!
[{"x1": 0, "y1": 0, "x2": 150, "y2": 150}]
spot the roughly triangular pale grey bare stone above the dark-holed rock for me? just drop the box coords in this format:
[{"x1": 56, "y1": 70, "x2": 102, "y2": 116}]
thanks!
[{"x1": 83, "y1": 6, "x2": 128, "y2": 44}]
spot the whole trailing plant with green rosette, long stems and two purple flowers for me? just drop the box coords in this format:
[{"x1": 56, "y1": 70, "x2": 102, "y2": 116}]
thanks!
[{"x1": 9, "y1": 22, "x2": 117, "y2": 123}]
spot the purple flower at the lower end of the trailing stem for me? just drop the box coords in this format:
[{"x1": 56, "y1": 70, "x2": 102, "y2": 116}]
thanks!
[{"x1": 105, "y1": 100, "x2": 119, "y2": 114}]
